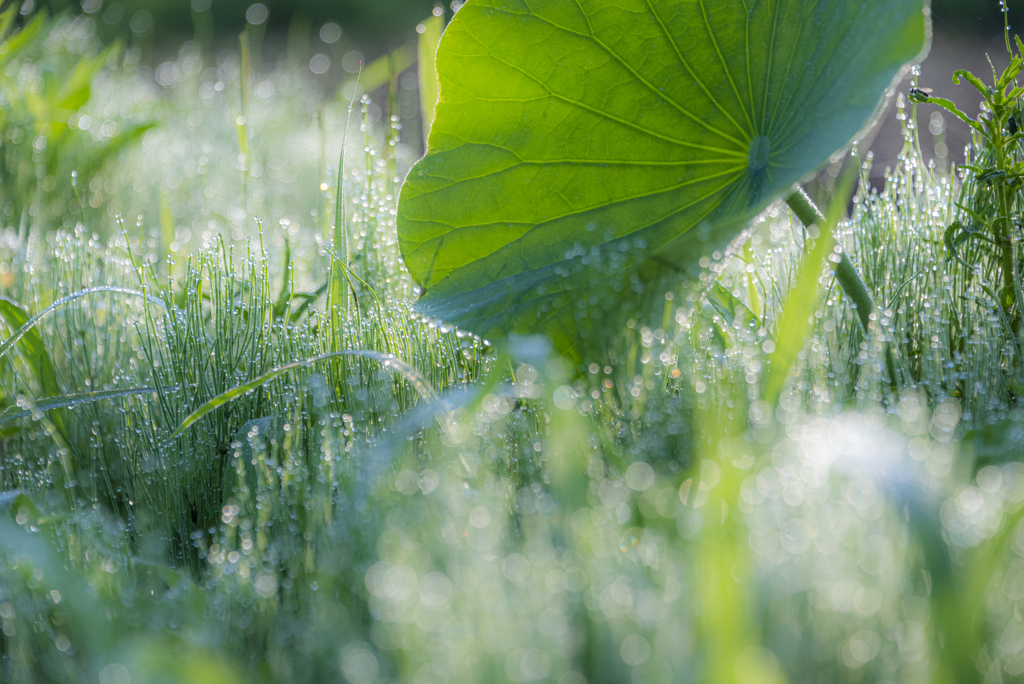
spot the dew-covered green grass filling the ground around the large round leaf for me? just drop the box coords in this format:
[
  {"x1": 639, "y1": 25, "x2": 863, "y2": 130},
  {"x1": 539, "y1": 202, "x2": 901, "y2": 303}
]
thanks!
[{"x1": 6, "y1": 7, "x2": 1024, "y2": 684}]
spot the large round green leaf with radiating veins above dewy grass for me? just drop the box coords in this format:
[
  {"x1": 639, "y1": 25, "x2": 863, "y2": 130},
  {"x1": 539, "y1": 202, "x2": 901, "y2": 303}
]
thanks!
[{"x1": 398, "y1": 0, "x2": 930, "y2": 335}]
